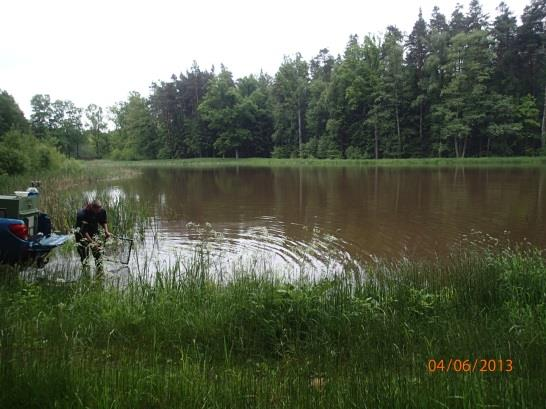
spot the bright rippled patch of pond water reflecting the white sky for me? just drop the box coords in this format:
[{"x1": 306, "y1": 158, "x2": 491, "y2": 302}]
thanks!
[{"x1": 133, "y1": 216, "x2": 359, "y2": 276}]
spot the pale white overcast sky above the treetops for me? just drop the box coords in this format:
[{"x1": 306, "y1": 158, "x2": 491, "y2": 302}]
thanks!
[{"x1": 0, "y1": 0, "x2": 530, "y2": 118}]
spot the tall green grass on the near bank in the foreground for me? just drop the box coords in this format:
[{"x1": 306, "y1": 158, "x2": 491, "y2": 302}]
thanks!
[{"x1": 0, "y1": 247, "x2": 546, "y2": 408}]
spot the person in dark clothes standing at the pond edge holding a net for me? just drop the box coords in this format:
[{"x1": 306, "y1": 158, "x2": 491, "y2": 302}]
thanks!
[{"x1": 75, "y1": 199, "x2": 110, "y2": 278}]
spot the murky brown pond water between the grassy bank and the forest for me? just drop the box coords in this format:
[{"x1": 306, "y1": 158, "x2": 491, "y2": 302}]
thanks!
[{"x1": 83, "y1": 167, "x2": 546, "y2": 273}]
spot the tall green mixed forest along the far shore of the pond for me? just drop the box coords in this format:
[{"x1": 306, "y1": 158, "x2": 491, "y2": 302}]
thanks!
[{"x1": 0, "y1": 0, "x2": 546, "y2": 173}]
